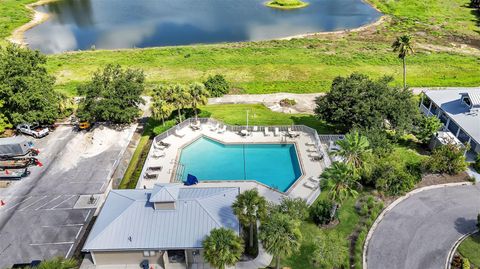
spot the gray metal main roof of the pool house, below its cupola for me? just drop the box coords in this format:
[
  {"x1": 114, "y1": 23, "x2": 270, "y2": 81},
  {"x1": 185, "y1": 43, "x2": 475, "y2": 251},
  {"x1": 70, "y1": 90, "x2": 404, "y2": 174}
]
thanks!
[{"x1": 84, "y1": 184, "x2": 240, "y2": 251}]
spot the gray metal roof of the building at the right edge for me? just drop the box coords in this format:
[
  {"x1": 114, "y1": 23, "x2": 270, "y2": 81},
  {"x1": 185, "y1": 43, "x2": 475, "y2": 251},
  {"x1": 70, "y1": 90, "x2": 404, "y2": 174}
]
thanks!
[{"x1": 425, "y1": 88, "x2": 480, "y2": 143}]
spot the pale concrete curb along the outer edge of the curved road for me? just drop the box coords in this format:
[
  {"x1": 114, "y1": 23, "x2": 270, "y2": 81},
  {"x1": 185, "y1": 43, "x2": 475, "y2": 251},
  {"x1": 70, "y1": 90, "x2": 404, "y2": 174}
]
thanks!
[{"x1": 362, "y1": 181, "x2": 473, "y2": 269}]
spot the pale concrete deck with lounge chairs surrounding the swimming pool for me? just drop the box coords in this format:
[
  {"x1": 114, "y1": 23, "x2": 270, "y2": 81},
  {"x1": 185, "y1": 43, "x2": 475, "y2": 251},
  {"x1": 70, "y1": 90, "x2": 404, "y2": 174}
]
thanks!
[{"x1": 137, "y1": 120, "x2": 334, "y2": 202}]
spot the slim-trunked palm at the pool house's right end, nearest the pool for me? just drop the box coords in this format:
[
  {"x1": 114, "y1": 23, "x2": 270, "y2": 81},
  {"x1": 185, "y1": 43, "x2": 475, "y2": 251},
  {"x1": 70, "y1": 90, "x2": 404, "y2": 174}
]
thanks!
[{"x1": 232, "y1": 189, "x2": 267, "y2": 247}]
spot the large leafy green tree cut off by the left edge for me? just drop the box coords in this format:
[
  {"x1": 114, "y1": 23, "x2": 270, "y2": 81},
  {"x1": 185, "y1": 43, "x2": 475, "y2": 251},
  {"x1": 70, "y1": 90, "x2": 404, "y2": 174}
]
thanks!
[{"x1": 0, "y1": 44, "x2": 59, "y2": 124}]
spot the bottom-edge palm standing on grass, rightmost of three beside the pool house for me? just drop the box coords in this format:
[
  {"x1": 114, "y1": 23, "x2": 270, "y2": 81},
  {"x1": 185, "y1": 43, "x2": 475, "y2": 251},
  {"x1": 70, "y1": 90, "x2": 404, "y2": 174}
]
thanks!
[{"x1": 259, "y1": 213, "x2": 302, "y2": 269}]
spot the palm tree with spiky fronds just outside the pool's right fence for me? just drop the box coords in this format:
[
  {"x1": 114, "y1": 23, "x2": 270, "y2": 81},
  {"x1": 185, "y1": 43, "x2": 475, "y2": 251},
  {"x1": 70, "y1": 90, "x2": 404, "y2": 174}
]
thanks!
[{"x1": 333, "y1": 131, "x2": 370, "y2": 172}]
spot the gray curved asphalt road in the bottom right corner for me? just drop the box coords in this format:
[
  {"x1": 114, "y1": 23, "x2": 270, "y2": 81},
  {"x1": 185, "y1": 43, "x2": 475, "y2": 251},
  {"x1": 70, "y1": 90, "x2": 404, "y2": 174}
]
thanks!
[{"x1": 367, "y1": 186, "x2": 480, "y2": 269}]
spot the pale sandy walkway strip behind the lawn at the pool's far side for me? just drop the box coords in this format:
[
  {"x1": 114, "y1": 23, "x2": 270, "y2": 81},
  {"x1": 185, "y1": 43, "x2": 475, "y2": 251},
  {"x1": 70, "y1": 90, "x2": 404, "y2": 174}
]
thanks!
[{"x1": 208, "y1": 93, "x2": 325, "y2": 114}]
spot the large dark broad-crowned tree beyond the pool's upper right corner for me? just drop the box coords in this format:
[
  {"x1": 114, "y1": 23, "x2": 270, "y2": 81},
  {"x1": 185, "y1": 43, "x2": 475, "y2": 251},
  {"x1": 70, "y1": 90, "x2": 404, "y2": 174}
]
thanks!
[{"x1": 315, "y1": 73, "x2": 420, "y2": 132}]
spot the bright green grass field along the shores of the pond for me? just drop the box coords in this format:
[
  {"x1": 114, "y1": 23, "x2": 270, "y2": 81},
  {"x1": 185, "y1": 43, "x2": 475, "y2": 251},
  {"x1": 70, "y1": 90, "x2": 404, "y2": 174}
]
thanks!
[{"x1": 0, "y1": 0, "x2": 480, "y2": 95}]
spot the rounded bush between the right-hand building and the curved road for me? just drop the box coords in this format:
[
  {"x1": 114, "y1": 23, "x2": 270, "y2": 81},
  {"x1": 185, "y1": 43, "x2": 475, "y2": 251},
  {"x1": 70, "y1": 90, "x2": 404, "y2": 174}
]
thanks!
[{"x1": 424, "y1": 144, "x2": 467, "y2": 175}]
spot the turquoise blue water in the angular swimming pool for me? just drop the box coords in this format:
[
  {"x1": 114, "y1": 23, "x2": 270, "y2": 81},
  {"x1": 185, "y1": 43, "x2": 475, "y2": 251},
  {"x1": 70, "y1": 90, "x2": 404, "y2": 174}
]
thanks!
[{"x1": 180, "y1": 137, "x2": 302, "y2": 192}]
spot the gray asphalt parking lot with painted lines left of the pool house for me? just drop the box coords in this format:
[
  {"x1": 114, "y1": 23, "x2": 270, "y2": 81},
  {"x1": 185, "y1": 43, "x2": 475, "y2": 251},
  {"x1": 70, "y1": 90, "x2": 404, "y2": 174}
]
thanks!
[{"x1": 0, "y1": 126, "x2": 134, "y2": 268}]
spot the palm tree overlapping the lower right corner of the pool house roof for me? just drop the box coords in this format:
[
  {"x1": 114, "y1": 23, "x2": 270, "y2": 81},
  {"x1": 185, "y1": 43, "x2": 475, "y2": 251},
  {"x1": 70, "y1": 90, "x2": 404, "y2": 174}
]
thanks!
[{"x1": 202, "y1": 228, "x2": 243, "y2": 269}]
